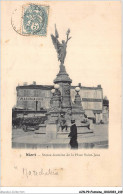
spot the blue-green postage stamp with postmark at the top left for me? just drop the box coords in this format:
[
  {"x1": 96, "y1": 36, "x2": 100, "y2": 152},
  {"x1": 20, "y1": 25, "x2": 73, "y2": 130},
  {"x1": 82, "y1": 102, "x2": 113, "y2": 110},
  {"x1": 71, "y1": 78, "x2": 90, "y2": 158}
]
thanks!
[{"x1": 22, "y1": 4, "x2": 49, "y2": 36}]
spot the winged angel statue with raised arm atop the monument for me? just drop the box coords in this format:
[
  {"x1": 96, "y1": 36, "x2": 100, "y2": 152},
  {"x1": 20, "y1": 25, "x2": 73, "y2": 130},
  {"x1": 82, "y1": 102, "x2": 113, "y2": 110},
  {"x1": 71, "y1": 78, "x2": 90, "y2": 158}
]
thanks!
[{"x1": 51, "y1": 25, "x2": 71, "y2": 65}]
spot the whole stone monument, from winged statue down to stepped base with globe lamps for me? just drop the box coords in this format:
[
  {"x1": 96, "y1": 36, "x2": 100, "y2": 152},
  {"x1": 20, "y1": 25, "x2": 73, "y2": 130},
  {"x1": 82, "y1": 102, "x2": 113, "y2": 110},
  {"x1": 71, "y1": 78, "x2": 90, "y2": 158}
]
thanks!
[{"x1": 46, "y1": 25, "x2": 93, "y2": 139}]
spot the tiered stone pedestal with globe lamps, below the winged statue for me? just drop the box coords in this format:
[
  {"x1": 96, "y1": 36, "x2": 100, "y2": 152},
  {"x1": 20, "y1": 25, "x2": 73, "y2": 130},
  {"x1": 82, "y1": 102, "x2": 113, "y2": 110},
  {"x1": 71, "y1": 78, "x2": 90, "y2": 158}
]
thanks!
[{"x1": 46, "y1": 65, "x2": 92, "y2": 141}]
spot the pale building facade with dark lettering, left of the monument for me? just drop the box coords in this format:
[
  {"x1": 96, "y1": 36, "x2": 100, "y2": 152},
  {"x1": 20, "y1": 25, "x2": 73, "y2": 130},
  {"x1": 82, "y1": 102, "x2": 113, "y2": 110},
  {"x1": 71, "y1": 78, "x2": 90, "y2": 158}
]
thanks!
[{"x1": 16, "y1": 84, "x2": 53, "y2": 111}]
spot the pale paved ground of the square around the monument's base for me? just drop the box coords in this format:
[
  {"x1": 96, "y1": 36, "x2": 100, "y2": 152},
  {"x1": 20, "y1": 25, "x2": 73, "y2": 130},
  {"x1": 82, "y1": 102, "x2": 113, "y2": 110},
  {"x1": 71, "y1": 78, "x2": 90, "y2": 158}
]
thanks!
[{"x1": 12, "y1": 124, "x2": 108, "y2": 148}]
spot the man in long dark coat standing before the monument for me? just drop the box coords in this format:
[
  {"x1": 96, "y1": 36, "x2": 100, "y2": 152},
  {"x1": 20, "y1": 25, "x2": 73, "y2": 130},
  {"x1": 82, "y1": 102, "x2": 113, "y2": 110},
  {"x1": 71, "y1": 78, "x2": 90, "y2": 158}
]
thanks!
[{"x1": 68, "y1": 120, "x2": 78, "y2": 149}]
